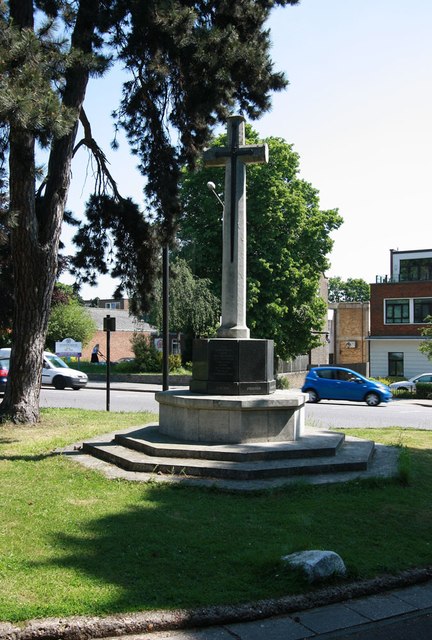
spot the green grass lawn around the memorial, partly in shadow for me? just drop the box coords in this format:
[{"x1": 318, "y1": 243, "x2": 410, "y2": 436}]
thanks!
[{"x1": 0, "y1": 409, "x2": 432, "y2": 621}]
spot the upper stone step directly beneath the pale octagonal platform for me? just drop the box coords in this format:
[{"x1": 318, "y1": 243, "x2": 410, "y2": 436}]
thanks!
[{"x1": 115, "y1": 425, "x2": 345, "y2": 462}]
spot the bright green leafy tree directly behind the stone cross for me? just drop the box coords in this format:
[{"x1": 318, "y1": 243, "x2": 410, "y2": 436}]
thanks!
[{"x1": 179, "y1": 127, "x2": 342, "y2": 359}]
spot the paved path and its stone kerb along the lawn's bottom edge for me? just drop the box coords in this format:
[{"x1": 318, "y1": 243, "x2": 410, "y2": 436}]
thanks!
[{"x1": 0, "y1": 568, "x2": 432, "y2": 640}]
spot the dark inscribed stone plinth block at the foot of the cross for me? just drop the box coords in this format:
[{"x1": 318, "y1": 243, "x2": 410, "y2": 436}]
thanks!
[{"x1": 190, "y1": 338, "x2": 276, "y2": 395}]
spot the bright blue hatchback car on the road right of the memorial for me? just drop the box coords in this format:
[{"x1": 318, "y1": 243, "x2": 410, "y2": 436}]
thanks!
[{"x1": 302, "y1": 367, "x2": 392, "y2": 407}]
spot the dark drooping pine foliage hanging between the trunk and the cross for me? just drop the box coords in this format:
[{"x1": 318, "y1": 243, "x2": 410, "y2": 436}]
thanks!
[{"x1": 71, "y1": 0, "x2": 297, "y2": 312}]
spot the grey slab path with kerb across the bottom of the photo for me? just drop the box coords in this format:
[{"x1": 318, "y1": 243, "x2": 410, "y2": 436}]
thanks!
[{"x1": 4, "y1": 580, "x2": 432, "y2": 640}]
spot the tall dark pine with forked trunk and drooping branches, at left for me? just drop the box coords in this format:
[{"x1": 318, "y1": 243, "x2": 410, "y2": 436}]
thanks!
[{"x1": 0, "y1": 0, "x2": 298, "y2": 422}]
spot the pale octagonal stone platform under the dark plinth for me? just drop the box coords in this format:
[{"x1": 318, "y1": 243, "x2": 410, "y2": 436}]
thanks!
[{"x1": 155, "y1": 390, "x2": 307, "y2": 444}]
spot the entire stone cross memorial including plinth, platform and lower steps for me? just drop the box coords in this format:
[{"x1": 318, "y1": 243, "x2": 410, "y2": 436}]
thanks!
[{"x1": 83, "y1": 115, "x2": 393, "y2": 490}]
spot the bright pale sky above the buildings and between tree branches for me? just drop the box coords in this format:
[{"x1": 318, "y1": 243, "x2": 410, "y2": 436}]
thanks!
[{"x1": 63, "y1": 0, "x2": 432, "y2": 297}]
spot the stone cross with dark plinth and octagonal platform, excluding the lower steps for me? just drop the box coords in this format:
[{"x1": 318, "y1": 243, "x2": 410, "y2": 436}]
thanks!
[{"x1": 156, "y1": 116, "x2": 305, "y2": 443}]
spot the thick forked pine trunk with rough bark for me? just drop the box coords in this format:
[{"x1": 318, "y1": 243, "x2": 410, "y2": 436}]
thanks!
[{"x1": 0, "y1": 0, "x2": 99, "y2": 423}]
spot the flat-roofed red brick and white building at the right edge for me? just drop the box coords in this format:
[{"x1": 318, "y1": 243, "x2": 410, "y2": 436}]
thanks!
[{"x1": 369, "y1": 249, "x2": 432, "y2": 378}]
